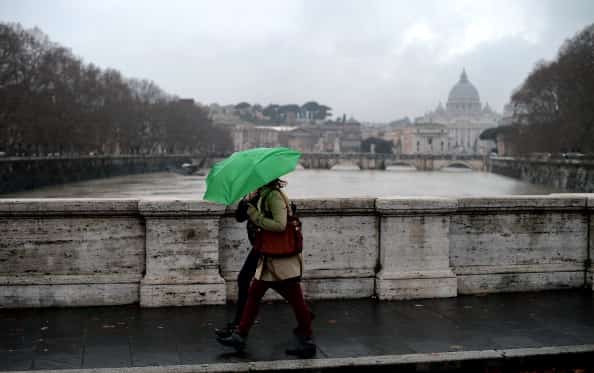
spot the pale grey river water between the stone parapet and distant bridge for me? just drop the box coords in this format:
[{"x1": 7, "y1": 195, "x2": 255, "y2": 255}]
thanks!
[{"x1": 0, "y1": 168, "x2": 557, "y2": 199}]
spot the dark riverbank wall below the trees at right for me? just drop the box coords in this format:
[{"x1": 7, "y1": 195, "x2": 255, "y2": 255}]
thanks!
[{"x1": 487, "y1": 157, "x2": 594, "y2": 193}]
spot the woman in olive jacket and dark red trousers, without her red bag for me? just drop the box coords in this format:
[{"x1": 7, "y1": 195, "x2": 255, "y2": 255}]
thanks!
[{"x1": 217, "y1": 179, "x2": 316, "y2": 358}]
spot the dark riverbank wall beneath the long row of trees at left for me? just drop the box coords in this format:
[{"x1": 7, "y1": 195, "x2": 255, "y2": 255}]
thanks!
[{"x1": 0, "y1": 155, "x2": 191, "y2": 194}]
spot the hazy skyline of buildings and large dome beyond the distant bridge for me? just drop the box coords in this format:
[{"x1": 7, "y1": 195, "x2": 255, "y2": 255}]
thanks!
[{"x1": 210, "y1": 70, "x2": 502, "y2": 155}]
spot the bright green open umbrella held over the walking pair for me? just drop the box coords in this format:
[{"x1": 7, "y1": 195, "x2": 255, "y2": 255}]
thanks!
[{"x1": 203, "y1": 148, "x2": 301, "y2": 205}]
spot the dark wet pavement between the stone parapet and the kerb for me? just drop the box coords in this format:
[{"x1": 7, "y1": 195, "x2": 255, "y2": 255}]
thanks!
[{"x1": 0, "y1": 290, "x2": 594, "y2": 371}]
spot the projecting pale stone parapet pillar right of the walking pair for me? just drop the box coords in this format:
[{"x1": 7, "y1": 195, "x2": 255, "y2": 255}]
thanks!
[{"x1": 376, "y1": 197, "x2": 457, "y2": 299}]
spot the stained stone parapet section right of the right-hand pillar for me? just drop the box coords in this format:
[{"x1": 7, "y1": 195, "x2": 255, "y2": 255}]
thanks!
[{"x1": 450, "y1": 195, "x2": 588, "y2": 294}]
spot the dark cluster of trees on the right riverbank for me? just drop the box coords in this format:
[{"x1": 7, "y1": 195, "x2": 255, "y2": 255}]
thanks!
[{"x1": 504, "y1": 24, "x2": 594, "y2": 153}]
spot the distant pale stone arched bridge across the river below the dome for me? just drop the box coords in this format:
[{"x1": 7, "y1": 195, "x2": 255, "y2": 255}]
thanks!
[{"x1": 299, "y1": 153, "x2": 486, "y2": 171}]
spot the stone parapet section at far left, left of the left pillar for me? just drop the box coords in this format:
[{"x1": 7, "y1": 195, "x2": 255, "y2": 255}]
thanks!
[{"x1": 0, "y1": 199, "x2": 145, "y2": 308}]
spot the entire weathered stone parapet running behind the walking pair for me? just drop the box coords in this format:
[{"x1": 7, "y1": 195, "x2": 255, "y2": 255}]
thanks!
[{"x1": 0, "y1": 194, "x2": 594, "y2": 307}]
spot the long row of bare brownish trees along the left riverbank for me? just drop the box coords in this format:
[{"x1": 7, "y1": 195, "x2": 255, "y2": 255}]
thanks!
[{"x1": 0, "y1": 23, "x2": 232, "y2": 156}]
